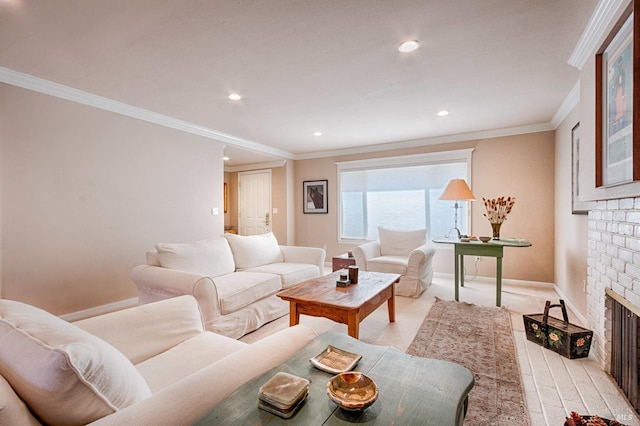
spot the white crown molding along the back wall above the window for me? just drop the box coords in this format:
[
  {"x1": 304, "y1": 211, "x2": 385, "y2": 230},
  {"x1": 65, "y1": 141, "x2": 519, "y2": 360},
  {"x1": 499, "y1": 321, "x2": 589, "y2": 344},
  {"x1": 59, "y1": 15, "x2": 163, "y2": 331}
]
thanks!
[{"x1": 295, "y1": 123, "x2": 555, "y2": 160}]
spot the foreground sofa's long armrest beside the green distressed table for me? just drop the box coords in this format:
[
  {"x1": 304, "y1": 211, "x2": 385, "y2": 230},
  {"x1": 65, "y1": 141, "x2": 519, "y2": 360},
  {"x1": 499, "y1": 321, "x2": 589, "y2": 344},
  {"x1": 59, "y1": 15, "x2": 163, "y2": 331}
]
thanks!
[{"x1": 91, "y1": 325, "x2": 317, "y2": 426}]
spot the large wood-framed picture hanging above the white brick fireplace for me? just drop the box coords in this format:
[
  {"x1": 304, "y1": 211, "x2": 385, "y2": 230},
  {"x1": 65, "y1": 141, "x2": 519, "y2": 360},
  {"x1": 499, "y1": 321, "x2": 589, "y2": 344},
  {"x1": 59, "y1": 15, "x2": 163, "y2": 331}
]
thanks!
[{"x1": 596, "y1": 0, "x2": 640, "y2": 187}]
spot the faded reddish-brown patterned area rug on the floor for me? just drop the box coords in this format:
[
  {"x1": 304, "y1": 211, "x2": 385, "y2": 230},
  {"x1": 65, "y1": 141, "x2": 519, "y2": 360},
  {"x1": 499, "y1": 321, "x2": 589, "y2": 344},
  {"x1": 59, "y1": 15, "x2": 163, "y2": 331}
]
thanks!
[{"x1": 407, "y1": 298, "x2": 529, "y2": 426}]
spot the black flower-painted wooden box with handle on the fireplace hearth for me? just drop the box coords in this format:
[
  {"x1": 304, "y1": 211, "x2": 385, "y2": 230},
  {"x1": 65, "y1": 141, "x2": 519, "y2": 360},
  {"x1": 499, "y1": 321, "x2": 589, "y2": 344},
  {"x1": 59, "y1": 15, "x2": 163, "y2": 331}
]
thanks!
[{"x1": 522, "y1": 300, "x2": 593, "y2": 359}]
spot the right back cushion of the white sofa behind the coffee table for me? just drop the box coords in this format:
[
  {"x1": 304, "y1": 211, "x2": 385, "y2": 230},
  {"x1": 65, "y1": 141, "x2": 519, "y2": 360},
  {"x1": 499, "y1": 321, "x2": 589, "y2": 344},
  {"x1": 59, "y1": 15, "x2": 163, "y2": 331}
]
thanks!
[{"x1": 224, "y1": 232, "x2": 283, "y2": 270}]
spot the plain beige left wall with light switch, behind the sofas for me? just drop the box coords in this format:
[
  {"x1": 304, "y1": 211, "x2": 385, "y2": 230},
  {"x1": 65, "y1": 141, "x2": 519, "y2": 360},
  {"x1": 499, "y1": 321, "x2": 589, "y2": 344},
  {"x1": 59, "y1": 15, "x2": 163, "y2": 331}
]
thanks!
[{"x1": 0, "y1": 85, "x2": 223, "y2": 314}]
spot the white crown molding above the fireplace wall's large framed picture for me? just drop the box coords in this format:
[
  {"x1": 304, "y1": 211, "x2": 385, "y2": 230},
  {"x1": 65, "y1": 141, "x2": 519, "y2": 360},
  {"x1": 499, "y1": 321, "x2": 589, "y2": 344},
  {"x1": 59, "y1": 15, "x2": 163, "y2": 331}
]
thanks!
[{"x1": 567, "y1": 0, "x2": 630, "y2": 70}]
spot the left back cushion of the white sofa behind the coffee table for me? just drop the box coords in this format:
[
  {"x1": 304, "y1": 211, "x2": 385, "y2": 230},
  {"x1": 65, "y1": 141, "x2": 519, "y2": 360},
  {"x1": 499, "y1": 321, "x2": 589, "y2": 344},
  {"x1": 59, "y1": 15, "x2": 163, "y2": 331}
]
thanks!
[{"x1": 156, "y1": 237, "x2": 236, "y2": 277}]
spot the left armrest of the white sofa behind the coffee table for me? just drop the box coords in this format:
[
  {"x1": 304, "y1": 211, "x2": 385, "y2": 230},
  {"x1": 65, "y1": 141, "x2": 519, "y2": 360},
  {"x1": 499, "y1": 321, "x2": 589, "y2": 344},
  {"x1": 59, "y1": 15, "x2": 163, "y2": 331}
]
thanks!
[{"x1": 131, "y1": 265, "x2": 222, "y2": 330}]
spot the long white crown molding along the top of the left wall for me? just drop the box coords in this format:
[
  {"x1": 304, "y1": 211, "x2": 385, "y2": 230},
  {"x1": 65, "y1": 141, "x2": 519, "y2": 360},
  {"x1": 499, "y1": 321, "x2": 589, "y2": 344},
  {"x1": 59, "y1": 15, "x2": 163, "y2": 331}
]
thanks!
[{"x1": 0, "y1": 67, "x2": 293, "y2": 159}]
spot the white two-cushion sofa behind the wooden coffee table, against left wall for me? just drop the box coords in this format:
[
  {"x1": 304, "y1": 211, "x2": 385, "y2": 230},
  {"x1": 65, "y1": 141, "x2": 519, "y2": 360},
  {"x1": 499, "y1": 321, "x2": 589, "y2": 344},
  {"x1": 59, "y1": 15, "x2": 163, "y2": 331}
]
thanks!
[{"x1": 131, "y1": 233, "x2": 325, "y2": 338}]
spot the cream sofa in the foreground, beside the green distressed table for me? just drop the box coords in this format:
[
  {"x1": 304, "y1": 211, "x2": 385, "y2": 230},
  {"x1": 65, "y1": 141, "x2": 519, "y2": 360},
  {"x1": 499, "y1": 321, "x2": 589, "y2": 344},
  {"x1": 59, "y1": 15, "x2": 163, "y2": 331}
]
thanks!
[{"x1": 0, "y1": 296, "x2": 316, "y2": 426}]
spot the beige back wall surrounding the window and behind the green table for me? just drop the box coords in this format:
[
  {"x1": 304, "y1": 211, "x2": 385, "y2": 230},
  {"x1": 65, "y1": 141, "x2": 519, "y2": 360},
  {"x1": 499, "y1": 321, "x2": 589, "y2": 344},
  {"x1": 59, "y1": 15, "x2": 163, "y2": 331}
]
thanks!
[{"x1": 295, "y1": 132, "x2": 555, "y2": 282}]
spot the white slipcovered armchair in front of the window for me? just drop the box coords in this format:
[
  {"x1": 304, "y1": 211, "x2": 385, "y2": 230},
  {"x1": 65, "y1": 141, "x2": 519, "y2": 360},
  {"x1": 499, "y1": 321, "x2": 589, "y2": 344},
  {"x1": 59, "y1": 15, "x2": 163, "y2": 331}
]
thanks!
[{"x1": 353, "y1": 228, "x2": 436, "y2": 297}]
